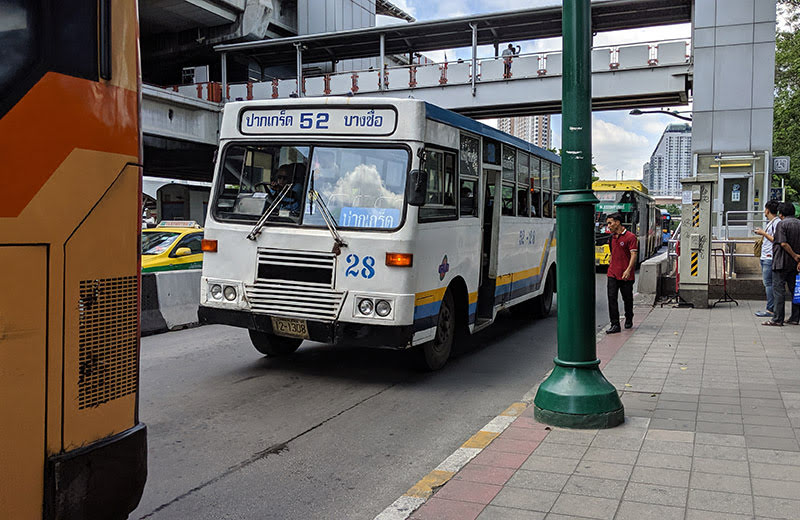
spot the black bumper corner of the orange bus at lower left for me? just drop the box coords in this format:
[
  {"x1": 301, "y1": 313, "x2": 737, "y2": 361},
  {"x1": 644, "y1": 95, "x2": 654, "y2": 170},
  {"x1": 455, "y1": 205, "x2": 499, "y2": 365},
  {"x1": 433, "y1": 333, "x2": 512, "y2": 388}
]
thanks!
[{"x1": 44, "y1": 423, "x2": 147, "y2": 520}]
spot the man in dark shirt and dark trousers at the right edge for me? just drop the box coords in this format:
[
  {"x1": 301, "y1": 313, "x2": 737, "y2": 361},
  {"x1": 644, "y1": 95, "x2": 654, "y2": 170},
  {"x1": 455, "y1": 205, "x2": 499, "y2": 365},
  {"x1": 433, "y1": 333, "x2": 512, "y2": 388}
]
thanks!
[{"x1": 764, "y1": 202, "x2": 800, "y2": 327}]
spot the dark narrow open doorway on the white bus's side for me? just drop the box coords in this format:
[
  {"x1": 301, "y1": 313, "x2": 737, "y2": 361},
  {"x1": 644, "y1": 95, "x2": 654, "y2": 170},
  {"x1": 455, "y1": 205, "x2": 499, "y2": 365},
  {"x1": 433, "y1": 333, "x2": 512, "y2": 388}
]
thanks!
[{"x1": 477, "y1": 168, "x2": 501, "y2": 320}]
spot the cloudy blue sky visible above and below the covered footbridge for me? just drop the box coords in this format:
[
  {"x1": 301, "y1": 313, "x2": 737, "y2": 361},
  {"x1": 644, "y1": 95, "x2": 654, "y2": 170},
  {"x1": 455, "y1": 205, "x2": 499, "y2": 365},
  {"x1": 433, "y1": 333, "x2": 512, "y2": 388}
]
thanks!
[{"x1": 377, "y1": 0, "x2": 691, "y2": 179}]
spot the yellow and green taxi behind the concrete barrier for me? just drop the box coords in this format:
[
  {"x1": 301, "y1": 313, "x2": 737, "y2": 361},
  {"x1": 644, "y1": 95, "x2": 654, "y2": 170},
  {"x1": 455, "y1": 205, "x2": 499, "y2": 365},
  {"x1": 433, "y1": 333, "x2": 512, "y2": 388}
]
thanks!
[{"x1": 142, "y1": 220, "x2": 203, "y2": 273}]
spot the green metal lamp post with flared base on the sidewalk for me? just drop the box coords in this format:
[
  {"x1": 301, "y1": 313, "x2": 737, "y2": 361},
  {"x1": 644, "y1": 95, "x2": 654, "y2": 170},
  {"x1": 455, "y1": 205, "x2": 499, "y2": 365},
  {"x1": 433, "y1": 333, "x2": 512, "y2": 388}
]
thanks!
[{"x1": 534, "y1": 0, "x2": 625, "y2": 428}]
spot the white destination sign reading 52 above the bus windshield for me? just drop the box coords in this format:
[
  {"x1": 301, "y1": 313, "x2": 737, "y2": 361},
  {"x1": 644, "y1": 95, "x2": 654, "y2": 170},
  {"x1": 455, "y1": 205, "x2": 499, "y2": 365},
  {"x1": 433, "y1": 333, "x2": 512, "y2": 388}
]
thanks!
[{"x1": 239, "y1": 107, "x2": 397, "y2": 135}]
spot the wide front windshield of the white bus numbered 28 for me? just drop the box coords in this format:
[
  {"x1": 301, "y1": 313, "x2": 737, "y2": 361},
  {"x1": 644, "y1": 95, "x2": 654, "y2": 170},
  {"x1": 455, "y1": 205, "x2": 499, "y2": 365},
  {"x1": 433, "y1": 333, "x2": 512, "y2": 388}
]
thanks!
[{"x1": 214, "y1": 144, "x2": 409, "y2": 229}]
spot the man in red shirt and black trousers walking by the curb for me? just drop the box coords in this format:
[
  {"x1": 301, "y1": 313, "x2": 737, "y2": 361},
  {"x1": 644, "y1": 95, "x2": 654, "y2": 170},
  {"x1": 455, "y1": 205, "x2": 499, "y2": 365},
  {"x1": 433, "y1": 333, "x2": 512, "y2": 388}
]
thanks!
[{"x1": 606, "y1": 213, "x2": 639, "y2": 334}]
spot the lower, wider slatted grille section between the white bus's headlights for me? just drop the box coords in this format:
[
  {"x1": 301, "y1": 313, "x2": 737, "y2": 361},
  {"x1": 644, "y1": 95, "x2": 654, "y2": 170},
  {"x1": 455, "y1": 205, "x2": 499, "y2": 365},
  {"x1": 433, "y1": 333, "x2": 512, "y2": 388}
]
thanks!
[{"x1": 245, "y1": 279, "x2": 344, "y2": 321}]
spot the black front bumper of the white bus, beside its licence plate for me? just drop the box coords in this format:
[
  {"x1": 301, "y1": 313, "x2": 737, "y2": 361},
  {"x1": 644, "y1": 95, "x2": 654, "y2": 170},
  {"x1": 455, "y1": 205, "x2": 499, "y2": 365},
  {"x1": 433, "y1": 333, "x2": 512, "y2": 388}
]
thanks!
[{"x1": 197, "y1": 305, "x2": 414, "y2": 349}]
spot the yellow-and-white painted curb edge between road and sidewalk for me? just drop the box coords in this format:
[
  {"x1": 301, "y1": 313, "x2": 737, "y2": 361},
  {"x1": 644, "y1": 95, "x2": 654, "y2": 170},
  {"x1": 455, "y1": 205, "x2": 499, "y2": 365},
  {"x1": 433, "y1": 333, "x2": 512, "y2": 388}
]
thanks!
[{"x1": 374, "y1": 304, "x2": 650, "y2": 520}]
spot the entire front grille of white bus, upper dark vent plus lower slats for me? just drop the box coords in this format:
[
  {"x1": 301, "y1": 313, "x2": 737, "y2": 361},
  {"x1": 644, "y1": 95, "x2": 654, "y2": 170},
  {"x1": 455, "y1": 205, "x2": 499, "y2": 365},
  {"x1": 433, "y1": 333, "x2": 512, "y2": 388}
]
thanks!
[{"x1": 250, "y1": 249, "x2": 345, "y2": 321}]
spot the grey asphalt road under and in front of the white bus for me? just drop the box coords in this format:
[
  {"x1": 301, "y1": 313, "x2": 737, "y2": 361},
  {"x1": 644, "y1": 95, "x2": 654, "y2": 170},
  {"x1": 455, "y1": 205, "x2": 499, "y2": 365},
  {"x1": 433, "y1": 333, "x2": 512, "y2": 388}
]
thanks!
[{"x1": 131, "y1": 274, "x2": 628, "y2": 520}]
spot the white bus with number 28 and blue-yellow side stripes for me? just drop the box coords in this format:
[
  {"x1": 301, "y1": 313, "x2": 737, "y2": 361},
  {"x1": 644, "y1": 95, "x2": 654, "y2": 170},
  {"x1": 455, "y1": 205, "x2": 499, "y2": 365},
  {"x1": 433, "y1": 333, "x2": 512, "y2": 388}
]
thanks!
[{"x1": 200, "y1": 98, "x2": 561, "y2": 370}]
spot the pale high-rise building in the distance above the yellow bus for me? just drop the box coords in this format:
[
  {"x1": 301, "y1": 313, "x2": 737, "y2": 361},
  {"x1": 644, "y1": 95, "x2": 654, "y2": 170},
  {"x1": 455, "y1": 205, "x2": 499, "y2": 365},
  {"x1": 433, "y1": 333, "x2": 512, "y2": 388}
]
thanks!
[{"x1": 645, "y1": 124, "x2": 692, "y2": 197}]
